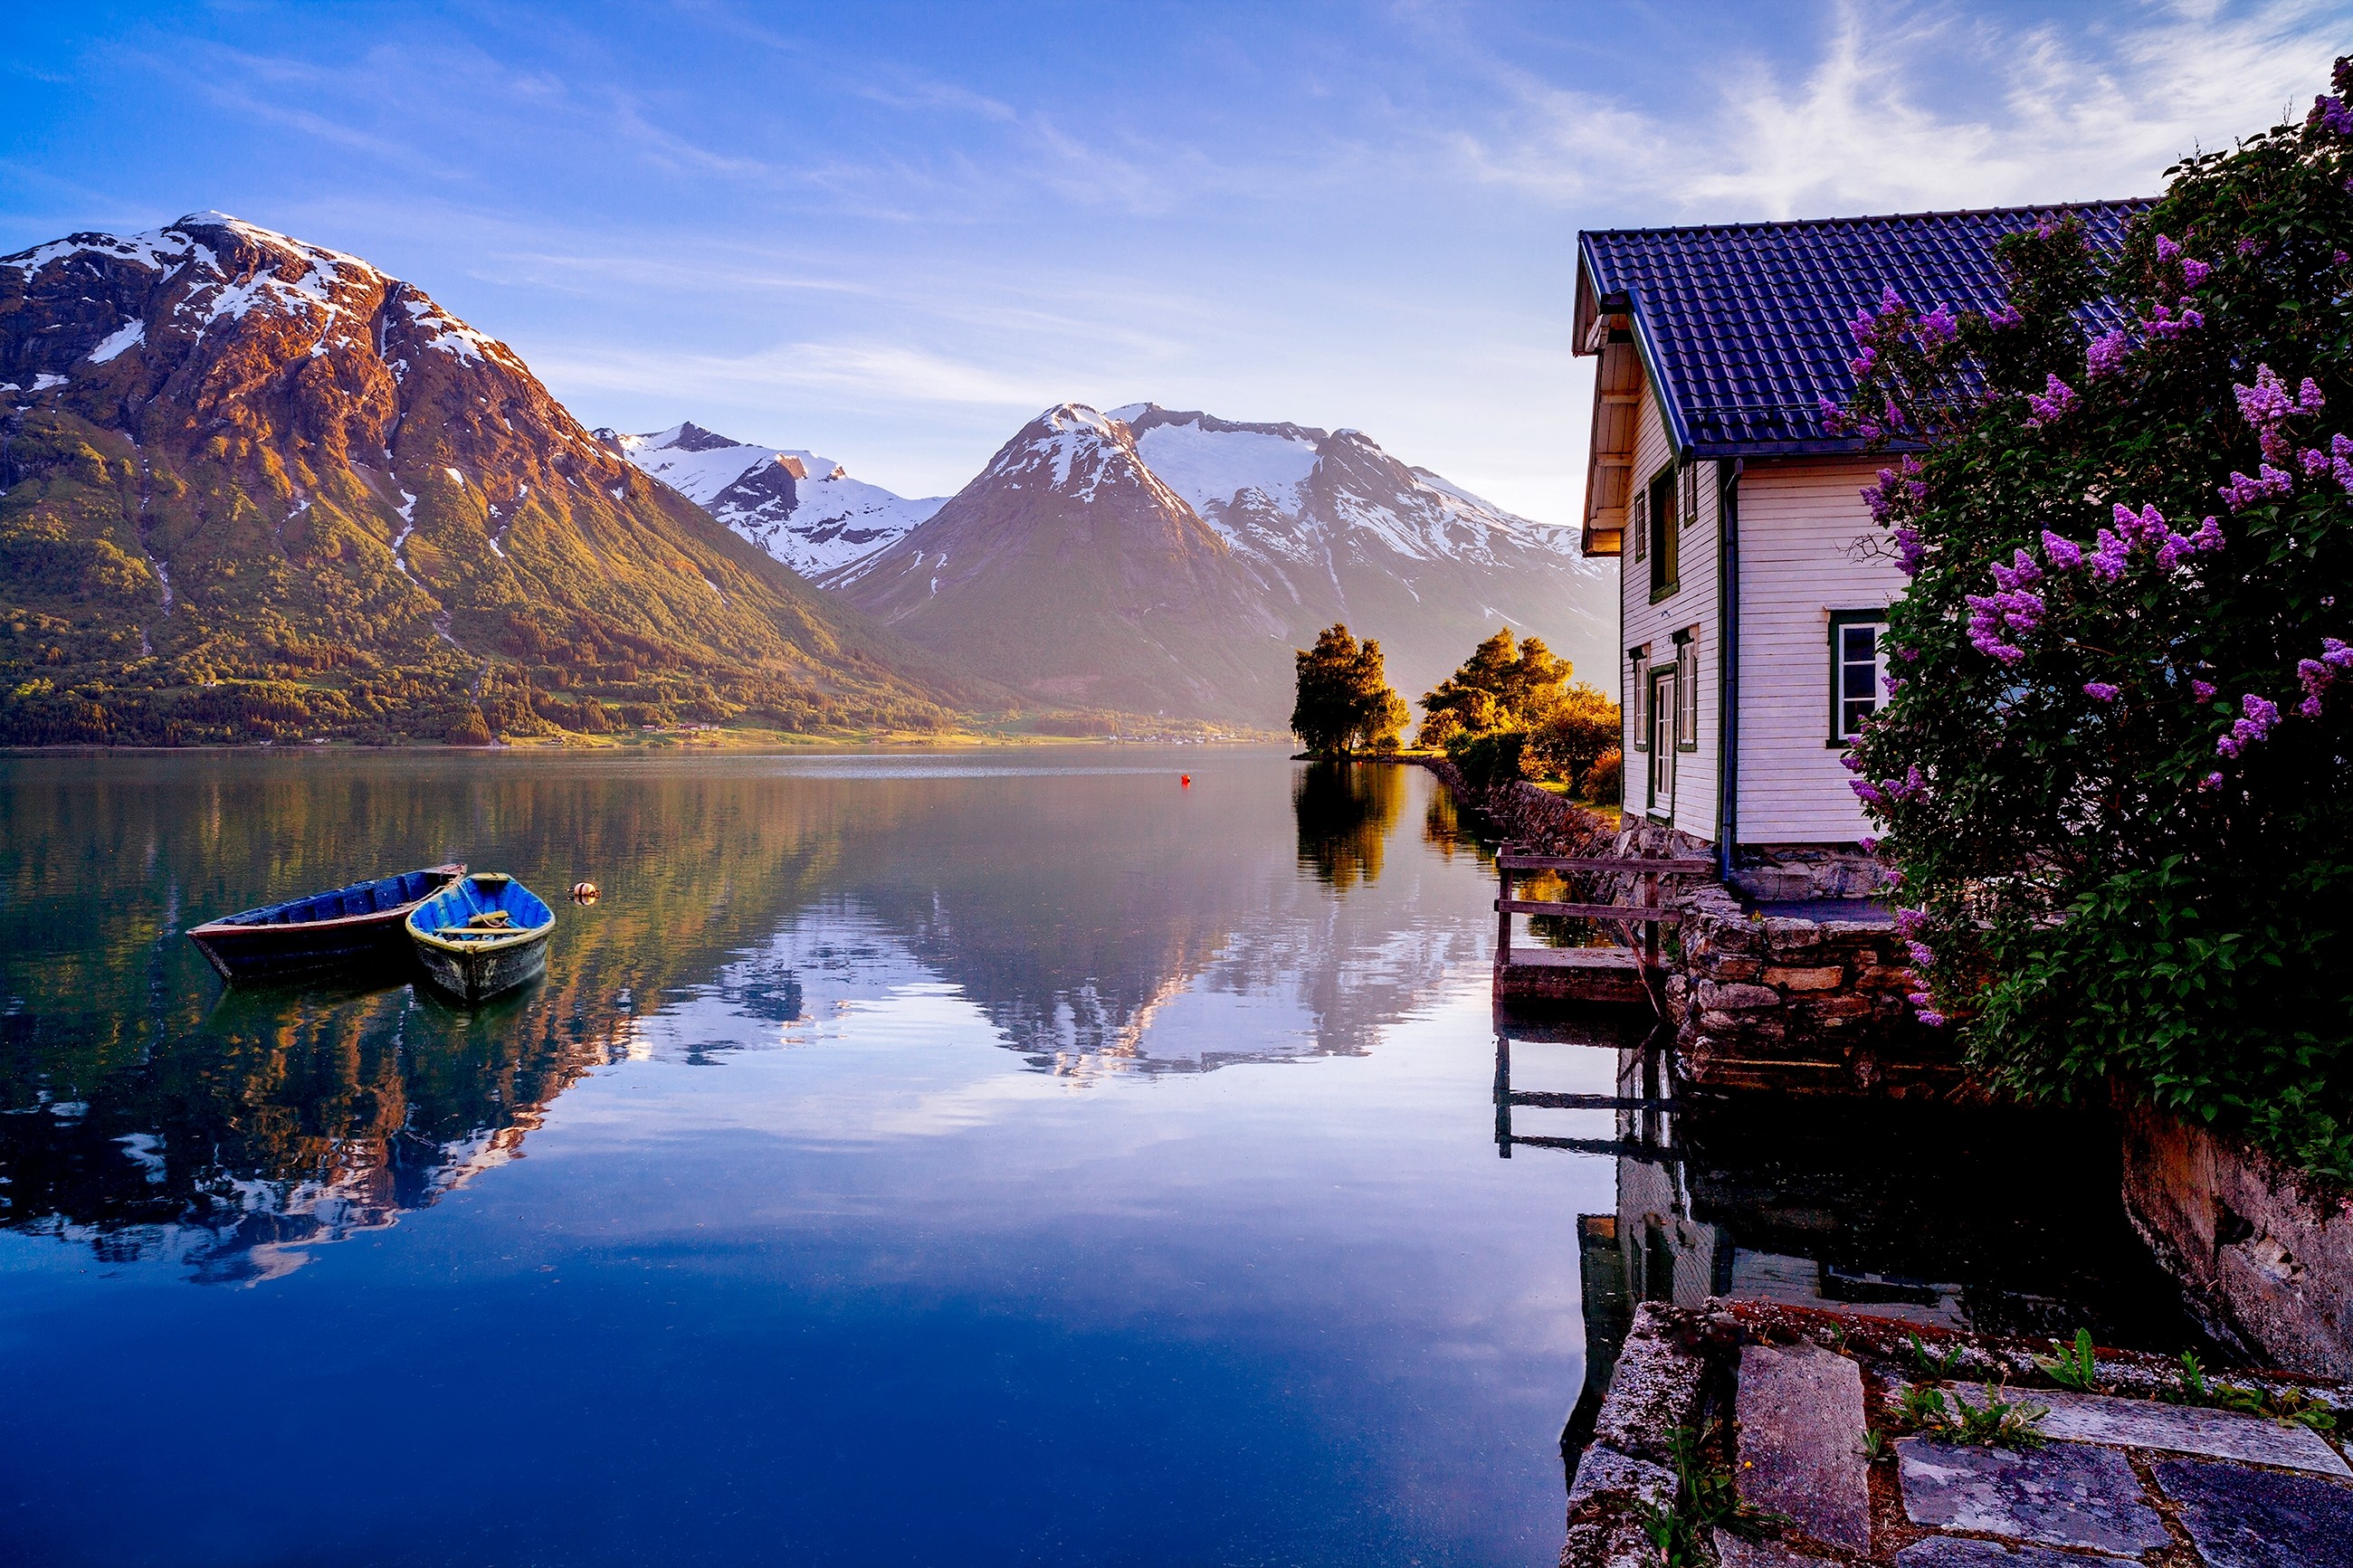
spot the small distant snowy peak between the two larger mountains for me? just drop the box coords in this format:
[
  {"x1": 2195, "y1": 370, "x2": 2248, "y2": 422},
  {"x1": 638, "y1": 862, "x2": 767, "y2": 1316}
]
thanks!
[{"x1": 597, "y1": 423, "x2": 946, "y2": 578}]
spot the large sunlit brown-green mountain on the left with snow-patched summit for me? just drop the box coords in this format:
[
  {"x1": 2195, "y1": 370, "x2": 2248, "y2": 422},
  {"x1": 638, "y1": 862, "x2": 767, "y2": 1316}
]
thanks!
[{"x1": 0, "y1": 212, "x2": 983, "y2": 740}]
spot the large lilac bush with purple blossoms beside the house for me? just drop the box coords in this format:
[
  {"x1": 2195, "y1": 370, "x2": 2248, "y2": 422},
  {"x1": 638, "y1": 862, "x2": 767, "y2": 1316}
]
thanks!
[{"x1": 1840, "y1": 62, "x2": 2353, "y2": 1178}]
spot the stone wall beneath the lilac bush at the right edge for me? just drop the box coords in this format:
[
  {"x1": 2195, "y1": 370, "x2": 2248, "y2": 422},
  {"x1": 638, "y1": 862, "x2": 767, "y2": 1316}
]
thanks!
[{"x1": 2120, "y1": 1098, "x2": 2353, "y2": 1378}]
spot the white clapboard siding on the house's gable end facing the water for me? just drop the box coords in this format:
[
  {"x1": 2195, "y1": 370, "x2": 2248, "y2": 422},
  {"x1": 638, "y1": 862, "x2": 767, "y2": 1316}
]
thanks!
[{"x1": 1596, "y1": 376, "x2": 1722, "y2": 841}]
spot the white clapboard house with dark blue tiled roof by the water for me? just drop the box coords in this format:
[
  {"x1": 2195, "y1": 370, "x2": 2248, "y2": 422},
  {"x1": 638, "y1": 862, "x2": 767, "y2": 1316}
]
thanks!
[{"x1": 1574, "y1": 202, "x2": 2148, "y2": 898}]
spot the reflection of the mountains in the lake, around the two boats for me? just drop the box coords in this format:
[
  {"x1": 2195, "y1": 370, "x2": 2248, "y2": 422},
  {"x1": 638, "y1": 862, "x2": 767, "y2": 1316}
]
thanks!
[{"x1": 0, "y1": 757, "x2": 1485, "y2": 1278}]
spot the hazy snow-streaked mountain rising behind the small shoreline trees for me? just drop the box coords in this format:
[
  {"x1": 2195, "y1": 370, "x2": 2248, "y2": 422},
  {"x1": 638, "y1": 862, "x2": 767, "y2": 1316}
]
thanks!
[{"x1": 819, "y1": 402, "x2": 1615, "y2": 727}]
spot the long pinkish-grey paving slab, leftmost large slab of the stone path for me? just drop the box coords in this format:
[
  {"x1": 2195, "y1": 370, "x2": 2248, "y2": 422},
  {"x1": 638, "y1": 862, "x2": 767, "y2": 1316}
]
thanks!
[{"x1": 1732, "y1": 1345, "x2": 1871, "y2": 1552}]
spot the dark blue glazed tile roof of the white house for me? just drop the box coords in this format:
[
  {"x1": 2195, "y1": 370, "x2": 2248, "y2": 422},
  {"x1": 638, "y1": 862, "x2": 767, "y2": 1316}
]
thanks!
[{"x1": 1577, "y1": 200, "x2": 2150, "y2": 456}]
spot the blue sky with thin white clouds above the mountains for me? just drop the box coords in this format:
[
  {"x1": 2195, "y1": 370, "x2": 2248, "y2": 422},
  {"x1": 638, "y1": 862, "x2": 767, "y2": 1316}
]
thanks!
[{"x1": 0, "y1": 0, "x2": 2353, "y2": 522}]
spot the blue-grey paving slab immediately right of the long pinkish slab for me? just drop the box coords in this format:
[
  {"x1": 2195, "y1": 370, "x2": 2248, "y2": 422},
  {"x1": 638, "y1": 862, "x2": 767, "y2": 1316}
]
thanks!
[{"x1": 1897, "y1": 1437, "x2": 2169, "y2": 1552}]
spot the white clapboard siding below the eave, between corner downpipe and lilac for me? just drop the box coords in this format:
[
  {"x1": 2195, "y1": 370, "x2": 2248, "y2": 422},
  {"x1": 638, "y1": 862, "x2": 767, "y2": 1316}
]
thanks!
[{"x1": 1731, "y1": 459, "x2": 1906, "y2": 844}]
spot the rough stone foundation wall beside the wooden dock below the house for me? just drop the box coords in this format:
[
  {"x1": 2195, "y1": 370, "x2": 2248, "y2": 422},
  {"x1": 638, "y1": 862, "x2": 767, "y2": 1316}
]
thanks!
[{"x1": 1666, "y1": 884, "x2": 1960, "y2": 1096}]
